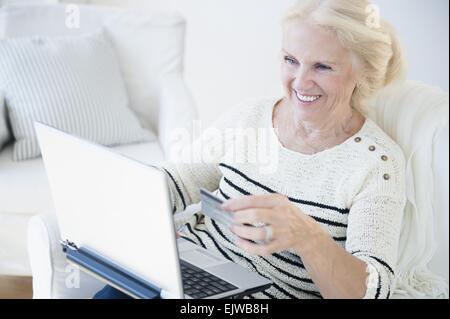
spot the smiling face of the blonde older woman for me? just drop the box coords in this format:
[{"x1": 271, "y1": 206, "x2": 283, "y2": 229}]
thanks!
[{"x1": 281, "y1": 22, "x2": 356, "y2": 121}]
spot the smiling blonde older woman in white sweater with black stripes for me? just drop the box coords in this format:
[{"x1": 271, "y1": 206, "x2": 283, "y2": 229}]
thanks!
[{"x1": 95, "y1": 0, "x2": 405, "y2": 298}]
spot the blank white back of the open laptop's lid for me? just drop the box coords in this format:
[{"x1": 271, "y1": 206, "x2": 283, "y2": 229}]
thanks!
[{"x1": 35, "y1": 123, "x2": 183, "y2": 298}]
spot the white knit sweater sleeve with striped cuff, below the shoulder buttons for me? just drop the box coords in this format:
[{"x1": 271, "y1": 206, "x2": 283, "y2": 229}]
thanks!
[{"x1": 345, "y1": 150, "x2": 406, "y2": 299}]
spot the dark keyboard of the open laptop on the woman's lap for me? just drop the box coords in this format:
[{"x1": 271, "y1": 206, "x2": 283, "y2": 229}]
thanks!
[{"x1": 180, "y1": 260, "x2": 238, "y2": 299}]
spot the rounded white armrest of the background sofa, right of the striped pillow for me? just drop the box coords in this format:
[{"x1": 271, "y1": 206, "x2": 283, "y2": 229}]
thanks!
[{"x1": 158, "y1": 73, "x2": 198, "y2": 161}]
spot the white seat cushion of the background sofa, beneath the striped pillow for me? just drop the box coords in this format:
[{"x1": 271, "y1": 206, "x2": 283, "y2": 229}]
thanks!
[{"x1": 0, "y1": 142, "x2": 163, "y2": 215}]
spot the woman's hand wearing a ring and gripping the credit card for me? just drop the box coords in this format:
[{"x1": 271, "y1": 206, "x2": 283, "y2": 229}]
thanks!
[{"x1": 222, "y1": 194, "x2": 325, "y2": 255}]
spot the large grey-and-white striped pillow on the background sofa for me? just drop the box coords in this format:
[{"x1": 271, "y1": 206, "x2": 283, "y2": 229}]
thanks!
[{"x1": 0, "y1": 32, "x2": 155, "y2": 160}]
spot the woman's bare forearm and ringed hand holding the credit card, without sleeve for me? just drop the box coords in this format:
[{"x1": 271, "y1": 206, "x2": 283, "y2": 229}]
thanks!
[{"x1": 224, "y1": 194, "x2": 368, "y2": 298}]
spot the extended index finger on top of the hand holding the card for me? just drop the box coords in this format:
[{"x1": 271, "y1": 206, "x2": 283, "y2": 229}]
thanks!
[{"x1": 222, "y1": 193, "x2": 287, "y2": 211}]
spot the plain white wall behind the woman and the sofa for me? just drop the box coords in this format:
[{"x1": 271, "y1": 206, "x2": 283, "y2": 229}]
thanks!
[{"x1": 78, "y1": 0, "x2": 449, "y2": 120}]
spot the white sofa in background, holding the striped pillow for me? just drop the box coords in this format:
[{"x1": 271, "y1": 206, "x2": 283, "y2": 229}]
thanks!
[{"x1": 0, "y1": 5, "x2": 197, "y2": 278}]
